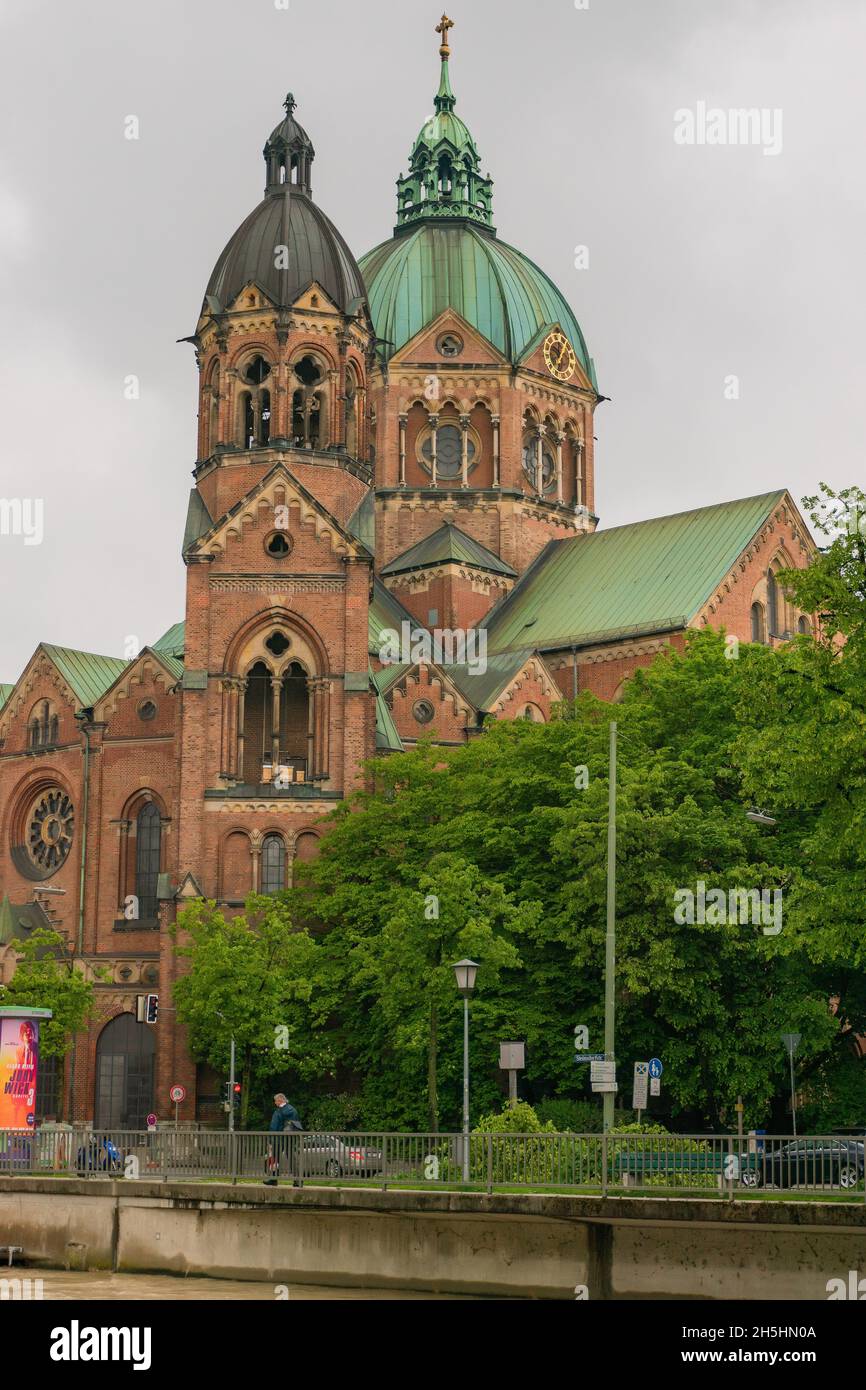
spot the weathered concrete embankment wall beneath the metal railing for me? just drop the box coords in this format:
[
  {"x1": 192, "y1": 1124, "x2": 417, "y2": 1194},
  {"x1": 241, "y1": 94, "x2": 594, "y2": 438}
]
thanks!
[{"x1": 0, "y1": 1177, "x2": 866, "y2": 1300}]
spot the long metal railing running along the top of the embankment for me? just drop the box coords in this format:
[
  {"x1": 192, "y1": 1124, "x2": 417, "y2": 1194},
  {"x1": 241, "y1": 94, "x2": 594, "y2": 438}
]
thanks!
[{"x1": 0, "y1": 1126, "x2": 866, "y2": 1200}]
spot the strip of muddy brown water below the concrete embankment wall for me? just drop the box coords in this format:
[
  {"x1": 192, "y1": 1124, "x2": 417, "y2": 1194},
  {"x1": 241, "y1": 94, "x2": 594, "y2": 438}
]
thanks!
[{"x1": 30, "y1": 1268, "x2": 483, "y2": 1302}]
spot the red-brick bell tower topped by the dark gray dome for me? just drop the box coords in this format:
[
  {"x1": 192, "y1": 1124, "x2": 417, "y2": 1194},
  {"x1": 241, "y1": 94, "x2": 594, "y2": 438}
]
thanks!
[{"x1": 173, "y1": 93, "x2": 375, "y2": 902}]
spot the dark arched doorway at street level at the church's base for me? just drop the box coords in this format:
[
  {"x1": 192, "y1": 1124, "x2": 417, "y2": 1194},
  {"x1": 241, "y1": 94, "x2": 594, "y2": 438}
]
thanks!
[{"x1": 93, "y1": 1013, "x2": 156, "y2": 1130}]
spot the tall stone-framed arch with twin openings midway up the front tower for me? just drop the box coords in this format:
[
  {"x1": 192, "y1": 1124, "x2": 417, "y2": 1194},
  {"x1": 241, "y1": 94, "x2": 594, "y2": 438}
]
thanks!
[{"x1": 221, "y1": 607, "x2": 331, "y2": 790}]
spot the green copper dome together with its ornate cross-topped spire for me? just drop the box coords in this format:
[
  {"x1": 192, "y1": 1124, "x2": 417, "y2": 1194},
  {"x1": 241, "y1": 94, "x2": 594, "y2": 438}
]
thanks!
[{"x1": 359, "y1": 15, "x2": 598, "y2": 389}]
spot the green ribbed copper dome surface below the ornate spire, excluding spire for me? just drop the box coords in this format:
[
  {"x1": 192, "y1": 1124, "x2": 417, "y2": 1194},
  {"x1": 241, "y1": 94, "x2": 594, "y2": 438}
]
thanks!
[{"x1": 360, "y1": 222, "x2": 598, "y2": 389}]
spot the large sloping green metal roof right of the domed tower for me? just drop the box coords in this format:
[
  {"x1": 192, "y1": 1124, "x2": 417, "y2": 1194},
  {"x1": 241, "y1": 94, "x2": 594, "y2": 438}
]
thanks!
[{"x1": 487, "y1": 491, "x2": 785, "y2": 652}]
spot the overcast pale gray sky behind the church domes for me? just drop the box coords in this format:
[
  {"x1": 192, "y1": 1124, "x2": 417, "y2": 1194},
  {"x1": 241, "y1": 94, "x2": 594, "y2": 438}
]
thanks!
[{"x1": 0, "y1": 0, "x2": 866, "y2": 680}]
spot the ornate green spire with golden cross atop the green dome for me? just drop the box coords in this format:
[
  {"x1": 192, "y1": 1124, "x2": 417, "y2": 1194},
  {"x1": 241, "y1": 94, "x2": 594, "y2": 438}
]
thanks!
[{"x1": 396, "y1": 14, "x2": 493, "y2": 232}]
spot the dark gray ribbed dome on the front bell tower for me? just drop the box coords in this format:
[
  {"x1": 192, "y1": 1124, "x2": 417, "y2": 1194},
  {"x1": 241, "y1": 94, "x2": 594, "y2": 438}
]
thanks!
[{"x1": 206, "y1": 183, "x2": 367, "y2": 313}]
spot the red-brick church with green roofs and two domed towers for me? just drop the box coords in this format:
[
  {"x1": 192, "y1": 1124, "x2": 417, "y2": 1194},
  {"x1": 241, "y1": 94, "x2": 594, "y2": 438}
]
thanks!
[{"x1": 0, "y1": 17, "x2": 815, "y2": 1127}]
